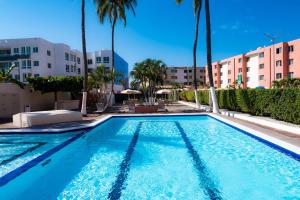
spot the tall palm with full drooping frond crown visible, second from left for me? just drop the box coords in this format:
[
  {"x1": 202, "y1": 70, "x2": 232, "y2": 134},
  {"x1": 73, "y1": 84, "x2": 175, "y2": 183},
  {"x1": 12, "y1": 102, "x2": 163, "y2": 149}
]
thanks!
[{"x1": 94, "y1": 0, "x2": 136, "y2": 101}]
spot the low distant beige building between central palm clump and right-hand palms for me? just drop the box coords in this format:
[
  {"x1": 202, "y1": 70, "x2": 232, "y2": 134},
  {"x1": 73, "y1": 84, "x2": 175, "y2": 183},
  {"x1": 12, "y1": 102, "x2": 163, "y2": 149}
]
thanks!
[{"x1": 165, "y1": 66, "x2": 206, "y2": 86}]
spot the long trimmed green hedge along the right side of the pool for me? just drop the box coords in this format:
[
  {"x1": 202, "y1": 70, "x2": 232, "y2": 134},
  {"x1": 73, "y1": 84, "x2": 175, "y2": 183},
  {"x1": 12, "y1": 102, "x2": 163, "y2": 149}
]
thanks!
[{"x1": 180, "y1": 88, "x2": 300, "y2": 124}]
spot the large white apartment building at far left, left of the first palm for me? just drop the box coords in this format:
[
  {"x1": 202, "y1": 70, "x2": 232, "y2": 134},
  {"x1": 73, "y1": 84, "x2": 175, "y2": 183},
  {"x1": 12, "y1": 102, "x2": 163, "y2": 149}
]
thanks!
[{"x1": 0, "y1": 38, "x2": 83, "y2": 82}]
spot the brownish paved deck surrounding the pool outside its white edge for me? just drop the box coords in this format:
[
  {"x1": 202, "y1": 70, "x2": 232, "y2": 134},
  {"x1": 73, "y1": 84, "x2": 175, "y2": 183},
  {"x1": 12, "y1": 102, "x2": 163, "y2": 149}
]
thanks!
[{"x1": 0, "y1": 103, "x2": 300, "y2": 147}]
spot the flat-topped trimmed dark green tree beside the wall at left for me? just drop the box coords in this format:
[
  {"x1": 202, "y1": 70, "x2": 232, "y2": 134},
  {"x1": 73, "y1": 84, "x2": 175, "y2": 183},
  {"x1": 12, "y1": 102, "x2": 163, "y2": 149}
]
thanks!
[{"x1": 27, "y1": 76, "x2": 83, "y2": 109}]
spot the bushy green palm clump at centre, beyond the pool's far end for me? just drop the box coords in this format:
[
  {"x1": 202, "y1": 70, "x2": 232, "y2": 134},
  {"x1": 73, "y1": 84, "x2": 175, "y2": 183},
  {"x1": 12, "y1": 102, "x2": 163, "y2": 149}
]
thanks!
[{"x1": 130, "y1": 59, "x2": 166, "y2": 103}]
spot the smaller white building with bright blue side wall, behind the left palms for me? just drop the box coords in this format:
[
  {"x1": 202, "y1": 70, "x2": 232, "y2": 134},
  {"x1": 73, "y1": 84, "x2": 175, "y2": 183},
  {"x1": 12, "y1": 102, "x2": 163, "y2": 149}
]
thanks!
[{"x1": 88, "y1": 50, "x2": 129, "y2": 92}]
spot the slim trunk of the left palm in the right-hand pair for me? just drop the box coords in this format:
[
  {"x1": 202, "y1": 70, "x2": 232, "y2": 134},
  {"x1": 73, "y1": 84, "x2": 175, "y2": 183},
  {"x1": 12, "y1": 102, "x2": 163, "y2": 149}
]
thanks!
[{"x1": 193, "y1": 3, "x2": 201, "y2": 109}]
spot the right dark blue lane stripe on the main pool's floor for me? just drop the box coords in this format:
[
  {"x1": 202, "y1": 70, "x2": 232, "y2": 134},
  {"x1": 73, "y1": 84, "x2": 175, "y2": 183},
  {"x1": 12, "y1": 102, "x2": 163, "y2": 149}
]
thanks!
[{"x1": 175, "y1": 122, "x2": 222, "y2": 200}]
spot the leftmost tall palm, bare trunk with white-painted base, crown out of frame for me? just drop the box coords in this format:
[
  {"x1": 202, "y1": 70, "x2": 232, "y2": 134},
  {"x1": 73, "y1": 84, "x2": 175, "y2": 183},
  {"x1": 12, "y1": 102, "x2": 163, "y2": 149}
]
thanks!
[{"x1": 81, "y1": 0, "x2": 88, "y2": 115}]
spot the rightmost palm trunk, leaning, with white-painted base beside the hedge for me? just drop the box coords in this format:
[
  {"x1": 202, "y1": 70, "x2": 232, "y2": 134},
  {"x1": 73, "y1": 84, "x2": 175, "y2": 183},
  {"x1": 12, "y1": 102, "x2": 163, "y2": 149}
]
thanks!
[{"x1": 205, "y1": 0, "x2": 220, "y2": 113}]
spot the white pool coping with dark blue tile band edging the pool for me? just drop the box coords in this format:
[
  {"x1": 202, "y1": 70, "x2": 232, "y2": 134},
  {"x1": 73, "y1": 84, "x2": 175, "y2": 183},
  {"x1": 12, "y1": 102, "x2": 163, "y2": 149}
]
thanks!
[{"x1": 0, "y1": 113, "x2": 300, "y2": 187}]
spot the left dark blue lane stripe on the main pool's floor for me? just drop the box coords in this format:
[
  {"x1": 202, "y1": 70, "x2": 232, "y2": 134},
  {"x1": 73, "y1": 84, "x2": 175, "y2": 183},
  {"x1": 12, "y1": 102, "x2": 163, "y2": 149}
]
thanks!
[{"x1": 108, "y1": 122, "x2": 142, "y2": 200}]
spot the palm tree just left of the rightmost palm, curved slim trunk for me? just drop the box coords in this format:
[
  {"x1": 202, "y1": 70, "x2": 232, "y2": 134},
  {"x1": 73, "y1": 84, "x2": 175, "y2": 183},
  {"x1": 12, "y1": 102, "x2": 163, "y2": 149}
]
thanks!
[{"x1": 176, "y1": 0, "x2": 202, "y2": 109}]
